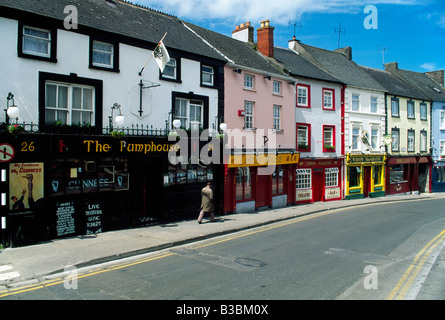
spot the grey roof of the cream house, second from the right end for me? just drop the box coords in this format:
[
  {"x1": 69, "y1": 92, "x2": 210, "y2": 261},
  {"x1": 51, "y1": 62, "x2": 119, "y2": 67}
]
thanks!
[{"x1": 361, "y1": 67, "x2": 430, "y2": 100}]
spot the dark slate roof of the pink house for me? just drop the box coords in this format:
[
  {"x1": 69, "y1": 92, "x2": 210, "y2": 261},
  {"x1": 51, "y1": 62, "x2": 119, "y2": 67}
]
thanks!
[{"x1": 185, "y1": 22, "x2": 288, "y2": 77}]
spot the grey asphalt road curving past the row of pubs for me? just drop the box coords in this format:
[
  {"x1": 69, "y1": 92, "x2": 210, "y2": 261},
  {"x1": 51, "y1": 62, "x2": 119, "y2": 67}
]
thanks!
[{"x1": 1, "y1": 199, "x2": 445, "y2": 301}]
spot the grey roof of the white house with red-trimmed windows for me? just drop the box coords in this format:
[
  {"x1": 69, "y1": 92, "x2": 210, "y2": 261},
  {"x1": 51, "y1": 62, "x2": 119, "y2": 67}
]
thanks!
[{"x1": 274, "y1": 47, "x2": 342, "y2": 82}]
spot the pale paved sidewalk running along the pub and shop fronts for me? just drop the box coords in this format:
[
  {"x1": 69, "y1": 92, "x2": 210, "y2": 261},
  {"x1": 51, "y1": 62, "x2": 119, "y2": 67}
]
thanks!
[{"x1": 0, "y1": 193, "x2": 445, "y2": 287}]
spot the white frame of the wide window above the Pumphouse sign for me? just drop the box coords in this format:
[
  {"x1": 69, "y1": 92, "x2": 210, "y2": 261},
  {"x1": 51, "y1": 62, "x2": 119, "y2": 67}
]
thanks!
[{"x1": 45, "y1": 81, "x2": 96, "y2": 126}]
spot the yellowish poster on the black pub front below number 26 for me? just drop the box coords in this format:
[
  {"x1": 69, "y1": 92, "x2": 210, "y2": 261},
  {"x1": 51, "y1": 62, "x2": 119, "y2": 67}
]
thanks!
[{"x1": 9, "y1": 163, "x2": 44, "y2": 212}]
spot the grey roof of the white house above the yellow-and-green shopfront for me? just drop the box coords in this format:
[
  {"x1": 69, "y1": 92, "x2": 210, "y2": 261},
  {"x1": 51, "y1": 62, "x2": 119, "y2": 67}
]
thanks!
[{"x1": 299, "y1": 43, "x2": 386, "y2": 91}]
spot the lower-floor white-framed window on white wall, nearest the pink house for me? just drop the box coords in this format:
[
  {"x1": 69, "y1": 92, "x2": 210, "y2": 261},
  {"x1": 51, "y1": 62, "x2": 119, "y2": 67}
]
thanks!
[{"x1": 175, "y1": 98, "x2": 204, "y2": 129}]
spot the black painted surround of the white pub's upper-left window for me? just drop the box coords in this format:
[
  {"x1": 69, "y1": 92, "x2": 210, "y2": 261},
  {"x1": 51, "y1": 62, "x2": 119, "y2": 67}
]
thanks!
[{"x1": 17, "y1": 21, "x2": 57, "y2": 63}]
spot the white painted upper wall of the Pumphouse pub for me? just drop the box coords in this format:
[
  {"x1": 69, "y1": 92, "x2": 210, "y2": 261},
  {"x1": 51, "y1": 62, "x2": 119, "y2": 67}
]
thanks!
[{"x1": 0, "y1": 18, "x2": 218, "y2": 129}]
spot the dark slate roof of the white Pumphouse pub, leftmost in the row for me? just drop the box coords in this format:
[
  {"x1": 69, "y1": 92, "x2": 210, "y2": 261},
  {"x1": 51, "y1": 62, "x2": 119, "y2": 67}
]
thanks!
[{"x1": 0, "y1": 0, "x2": 223, "y2": 60}]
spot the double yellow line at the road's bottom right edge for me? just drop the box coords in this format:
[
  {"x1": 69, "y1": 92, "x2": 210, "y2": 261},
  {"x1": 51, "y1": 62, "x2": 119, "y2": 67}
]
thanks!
[{"x1": 386, "y1": 230, "x2": 445, "y2": 300}]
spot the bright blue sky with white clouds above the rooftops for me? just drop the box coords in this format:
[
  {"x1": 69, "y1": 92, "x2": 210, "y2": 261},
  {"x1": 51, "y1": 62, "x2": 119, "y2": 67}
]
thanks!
[{"x1": 136, "y1": 0, "x2": 445, "y2": 72}]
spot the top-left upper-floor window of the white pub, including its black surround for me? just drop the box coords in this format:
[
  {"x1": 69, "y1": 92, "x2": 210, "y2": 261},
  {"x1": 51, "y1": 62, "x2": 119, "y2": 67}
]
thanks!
[{"x1": 17, "y1": 23, "x2": 57, "y2": 62}]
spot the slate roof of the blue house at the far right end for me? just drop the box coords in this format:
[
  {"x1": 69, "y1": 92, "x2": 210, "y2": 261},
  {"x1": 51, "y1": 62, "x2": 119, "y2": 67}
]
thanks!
[{"x1": 394, "y1": 69, "x2": 445, "y2": 101}]
